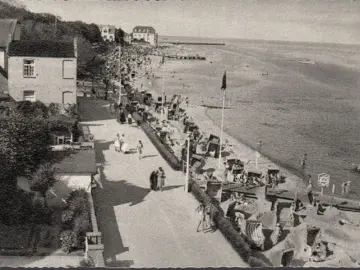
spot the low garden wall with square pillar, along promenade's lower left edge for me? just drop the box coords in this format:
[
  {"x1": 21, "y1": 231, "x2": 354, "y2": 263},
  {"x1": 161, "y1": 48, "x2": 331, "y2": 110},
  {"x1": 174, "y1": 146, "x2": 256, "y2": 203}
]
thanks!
[{"x1": 85, "y1": 193, "x2": 105, "y2": 267}]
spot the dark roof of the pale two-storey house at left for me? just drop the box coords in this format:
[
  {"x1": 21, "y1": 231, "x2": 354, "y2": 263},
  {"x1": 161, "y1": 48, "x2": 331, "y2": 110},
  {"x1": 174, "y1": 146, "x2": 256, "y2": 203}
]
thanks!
[{"x1": 8, "y1": 40, "x2": 75, "y2": 58}]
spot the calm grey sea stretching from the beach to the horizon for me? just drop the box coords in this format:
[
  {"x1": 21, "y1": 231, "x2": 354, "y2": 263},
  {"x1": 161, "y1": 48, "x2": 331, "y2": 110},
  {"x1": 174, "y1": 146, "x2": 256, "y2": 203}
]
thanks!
[{"x1": 159, "y1": 34, "x2": 360, "y2": 199}]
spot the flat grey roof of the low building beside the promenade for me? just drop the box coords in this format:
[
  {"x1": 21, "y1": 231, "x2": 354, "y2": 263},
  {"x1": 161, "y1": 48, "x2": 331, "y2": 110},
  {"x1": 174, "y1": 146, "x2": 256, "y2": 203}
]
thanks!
[{"x1": 53, "y1": 150, "x2": 96, "y2": 174}]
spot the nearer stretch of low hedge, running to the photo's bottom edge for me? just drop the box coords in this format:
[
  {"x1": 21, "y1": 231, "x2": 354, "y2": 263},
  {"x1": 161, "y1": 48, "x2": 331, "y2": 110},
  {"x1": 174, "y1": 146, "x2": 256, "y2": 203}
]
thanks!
[{"x1": 190, "y1": 179, "x2": 272, "y2": 267}]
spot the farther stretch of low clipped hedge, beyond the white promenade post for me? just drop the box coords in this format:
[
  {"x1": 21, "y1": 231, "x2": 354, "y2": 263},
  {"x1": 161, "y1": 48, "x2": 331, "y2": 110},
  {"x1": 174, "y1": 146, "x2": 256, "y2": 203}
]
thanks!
[{"x1": 132, "y1": 112, "x2": 181, "y2": 171}]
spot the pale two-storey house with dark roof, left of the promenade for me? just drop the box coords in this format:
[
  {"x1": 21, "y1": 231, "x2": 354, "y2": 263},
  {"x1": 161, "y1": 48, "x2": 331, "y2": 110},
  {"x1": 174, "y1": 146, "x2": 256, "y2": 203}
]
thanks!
[{"x1": 8, "y1": 39, "x2": 77, "y2": 105}]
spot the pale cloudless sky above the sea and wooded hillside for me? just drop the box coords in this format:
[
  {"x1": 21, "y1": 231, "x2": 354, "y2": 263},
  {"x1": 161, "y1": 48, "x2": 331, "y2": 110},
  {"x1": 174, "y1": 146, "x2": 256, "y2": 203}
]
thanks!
[{"x1": 18, "y1": 0, "x2": 360, "y2": 44}]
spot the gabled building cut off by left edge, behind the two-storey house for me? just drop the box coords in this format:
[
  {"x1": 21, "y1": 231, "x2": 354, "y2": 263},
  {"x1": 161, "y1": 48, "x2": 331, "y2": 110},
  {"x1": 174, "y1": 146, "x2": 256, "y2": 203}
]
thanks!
[{"x1": 0, "y1": 19, "x2": 21, "y2": 72}]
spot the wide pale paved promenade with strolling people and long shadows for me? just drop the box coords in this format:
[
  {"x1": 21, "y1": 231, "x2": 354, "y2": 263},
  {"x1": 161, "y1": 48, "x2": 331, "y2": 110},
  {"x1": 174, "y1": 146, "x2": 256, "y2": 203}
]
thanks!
[{"x1": 81, "y1": 100, "x2": 247, "y2": 268}]
